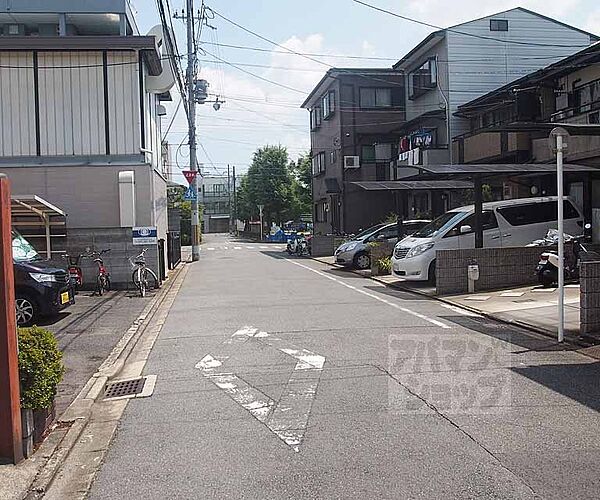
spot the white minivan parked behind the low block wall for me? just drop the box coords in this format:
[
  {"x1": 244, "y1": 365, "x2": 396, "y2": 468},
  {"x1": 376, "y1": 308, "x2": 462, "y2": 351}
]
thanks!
[{"x1": 392, "y1": 196, "x2": 583, "y2": 282}]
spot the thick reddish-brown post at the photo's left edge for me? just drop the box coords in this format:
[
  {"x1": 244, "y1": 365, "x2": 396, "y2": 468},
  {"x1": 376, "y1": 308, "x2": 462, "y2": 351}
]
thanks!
[{"x1": 0, "y1": 174, "x2": 23, "y2": 464}]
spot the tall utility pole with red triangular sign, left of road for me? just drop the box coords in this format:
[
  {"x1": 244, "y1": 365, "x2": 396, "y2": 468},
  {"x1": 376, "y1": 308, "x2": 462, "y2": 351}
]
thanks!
[{"x1": 186, "y1": 0, "x2": 200, "y2": 261}]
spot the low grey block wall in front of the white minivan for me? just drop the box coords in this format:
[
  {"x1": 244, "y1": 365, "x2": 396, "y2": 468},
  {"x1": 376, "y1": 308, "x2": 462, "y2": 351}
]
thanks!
[{"x1": 436, "y1": 247, "x2": 545, "y2": 295}]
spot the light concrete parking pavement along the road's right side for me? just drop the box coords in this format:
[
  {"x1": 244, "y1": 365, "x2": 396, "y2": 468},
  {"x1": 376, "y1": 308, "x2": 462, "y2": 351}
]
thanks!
[{"x1": 316, "y1": 257, "x2": 580, "y2": 338}]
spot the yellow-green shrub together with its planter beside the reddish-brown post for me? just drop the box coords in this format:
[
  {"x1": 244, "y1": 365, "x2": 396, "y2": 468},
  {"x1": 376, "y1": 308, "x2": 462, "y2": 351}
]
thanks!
[{"x1": 18, "y1": 326, "x2": 65, "y2": 456}]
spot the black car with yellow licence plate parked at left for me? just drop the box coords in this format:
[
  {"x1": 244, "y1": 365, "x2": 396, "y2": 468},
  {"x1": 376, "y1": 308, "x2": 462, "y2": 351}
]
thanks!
[{"x1": 12, "y1": 231, "x2": 74, "y2": 326}]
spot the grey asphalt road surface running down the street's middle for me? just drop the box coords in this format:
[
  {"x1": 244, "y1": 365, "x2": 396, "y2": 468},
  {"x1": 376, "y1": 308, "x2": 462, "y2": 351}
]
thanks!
[{"x1": 90, "y1": 236, "x2": 600, "y2": 500}]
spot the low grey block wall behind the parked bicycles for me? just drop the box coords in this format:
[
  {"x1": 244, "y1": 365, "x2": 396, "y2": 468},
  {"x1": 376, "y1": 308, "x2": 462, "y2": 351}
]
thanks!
[{"x1": 66, "y1": 227, "x2": 158, "y2": 290}]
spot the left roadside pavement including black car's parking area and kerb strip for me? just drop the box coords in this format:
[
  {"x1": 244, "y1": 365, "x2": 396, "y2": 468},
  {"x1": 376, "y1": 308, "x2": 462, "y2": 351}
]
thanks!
[{"x1": 0, "y1": 262, "x2": 187, "y2": 500}]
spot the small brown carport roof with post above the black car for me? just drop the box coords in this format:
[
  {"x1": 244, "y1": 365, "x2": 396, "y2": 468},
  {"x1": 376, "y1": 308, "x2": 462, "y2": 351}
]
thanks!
[{"x1": 11, "y1": 194, "x2": 67, "y2": 259}]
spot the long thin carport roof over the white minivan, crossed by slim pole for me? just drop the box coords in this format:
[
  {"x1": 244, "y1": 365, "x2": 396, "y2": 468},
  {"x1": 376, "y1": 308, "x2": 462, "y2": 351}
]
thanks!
[{"x1": 416, "y1": 163, "x2": 600, "y2": 177}]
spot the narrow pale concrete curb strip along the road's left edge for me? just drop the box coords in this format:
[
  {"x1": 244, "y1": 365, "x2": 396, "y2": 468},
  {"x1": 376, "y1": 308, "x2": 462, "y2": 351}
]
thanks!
[{"x1": 21, "y1": 261, "x2": 186, "y2": 500}]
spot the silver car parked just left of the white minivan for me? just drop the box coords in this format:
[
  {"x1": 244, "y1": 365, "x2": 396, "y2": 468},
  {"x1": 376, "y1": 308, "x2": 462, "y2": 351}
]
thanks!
[{"x1": 335, "y1": 220, "x2": 431, "y2": 269}]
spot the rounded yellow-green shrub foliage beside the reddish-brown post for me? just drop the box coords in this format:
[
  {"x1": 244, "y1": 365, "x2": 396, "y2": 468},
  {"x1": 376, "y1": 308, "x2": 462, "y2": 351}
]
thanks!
[{"x1": 19, "y1": 326, "x2": 65, "y2": 410}]
